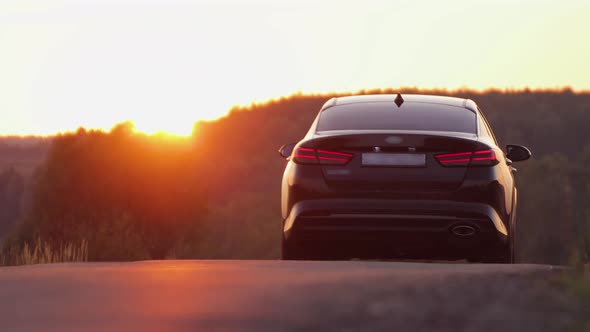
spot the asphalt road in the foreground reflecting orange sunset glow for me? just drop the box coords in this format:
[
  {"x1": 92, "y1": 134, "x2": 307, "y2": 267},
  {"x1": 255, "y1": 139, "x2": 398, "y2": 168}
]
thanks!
[{"x1": 0, "y1": 261, "x2": 590, "y2": 332}]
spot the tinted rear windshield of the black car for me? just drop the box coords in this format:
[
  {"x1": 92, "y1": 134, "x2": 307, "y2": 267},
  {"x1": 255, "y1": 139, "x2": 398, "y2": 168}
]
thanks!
[{"x1": 317, "y1": 103, "x2": 476, "y2": 134}]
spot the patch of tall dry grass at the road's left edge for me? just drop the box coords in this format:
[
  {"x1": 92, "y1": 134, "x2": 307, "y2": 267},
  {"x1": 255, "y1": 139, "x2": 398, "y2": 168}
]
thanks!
[{"x1": 0, "y1": 239, "x2": 88, "y2": 266}]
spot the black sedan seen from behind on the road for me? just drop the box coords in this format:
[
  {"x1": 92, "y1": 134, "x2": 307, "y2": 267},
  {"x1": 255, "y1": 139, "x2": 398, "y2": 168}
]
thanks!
[{"x1": 280, "y1": 94, "x2": 531, "y2": 263}]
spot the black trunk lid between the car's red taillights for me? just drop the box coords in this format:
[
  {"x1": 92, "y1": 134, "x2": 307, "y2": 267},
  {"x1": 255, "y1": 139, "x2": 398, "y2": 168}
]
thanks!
[{"x1": 312, "y1": 131, "x2": 482, "y2": 192}]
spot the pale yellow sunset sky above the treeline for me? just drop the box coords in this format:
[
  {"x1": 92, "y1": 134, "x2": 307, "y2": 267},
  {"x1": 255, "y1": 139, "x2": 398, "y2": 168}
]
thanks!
[{"x1": 0, "y1": 0, "x2": 590, "y2": 135}]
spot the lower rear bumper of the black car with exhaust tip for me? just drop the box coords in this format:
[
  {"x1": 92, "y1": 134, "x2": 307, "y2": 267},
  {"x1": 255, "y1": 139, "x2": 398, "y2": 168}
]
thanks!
[{"x1": 283, "y1": 199, "x2": 508, "y2": 257}]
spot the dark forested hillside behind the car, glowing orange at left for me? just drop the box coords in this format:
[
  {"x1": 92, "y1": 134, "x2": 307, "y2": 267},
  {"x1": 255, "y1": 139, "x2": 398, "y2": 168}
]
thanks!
[{"x1": 0, "y1": 89, "x2": 590, "y2": 263}]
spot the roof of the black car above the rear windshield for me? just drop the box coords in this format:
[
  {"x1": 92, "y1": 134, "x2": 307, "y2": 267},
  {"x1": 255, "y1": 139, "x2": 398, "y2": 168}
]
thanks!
[{"x1": 322, "y1": 94, "x2": 477, "y2": 112}]
